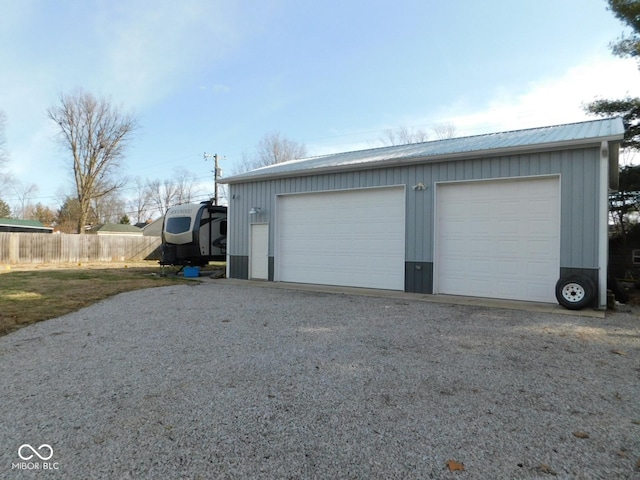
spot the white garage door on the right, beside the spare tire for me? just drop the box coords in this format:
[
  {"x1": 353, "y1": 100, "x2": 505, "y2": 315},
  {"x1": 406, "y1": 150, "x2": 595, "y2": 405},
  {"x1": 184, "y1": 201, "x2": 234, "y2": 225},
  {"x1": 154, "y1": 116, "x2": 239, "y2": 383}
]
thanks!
[{"x1": 434, "y1": 177, "x2": 560, "y2": 302}]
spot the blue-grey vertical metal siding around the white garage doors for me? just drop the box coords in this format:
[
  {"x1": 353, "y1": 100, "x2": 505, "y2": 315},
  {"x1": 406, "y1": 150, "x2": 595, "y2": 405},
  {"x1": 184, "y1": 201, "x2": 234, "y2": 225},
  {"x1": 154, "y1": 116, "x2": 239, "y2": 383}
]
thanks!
[{"x1": 229, "y1": 147, "x2": 599, "y2": 282}]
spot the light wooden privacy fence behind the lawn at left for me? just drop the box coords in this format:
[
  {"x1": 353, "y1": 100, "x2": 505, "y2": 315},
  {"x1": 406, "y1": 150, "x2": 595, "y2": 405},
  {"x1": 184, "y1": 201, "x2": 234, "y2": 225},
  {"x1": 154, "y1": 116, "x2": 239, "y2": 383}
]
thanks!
[{"x1": 0, "y1": 232, "x2": 161, "y2": 264}]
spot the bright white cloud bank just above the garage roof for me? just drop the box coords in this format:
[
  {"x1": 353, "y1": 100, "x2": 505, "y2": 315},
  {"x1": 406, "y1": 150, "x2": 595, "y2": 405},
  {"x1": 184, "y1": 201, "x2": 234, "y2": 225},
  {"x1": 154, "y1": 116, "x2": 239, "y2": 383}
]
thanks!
[{"x1": 308, "y1": 56, "x2": 640, "y2": 155}]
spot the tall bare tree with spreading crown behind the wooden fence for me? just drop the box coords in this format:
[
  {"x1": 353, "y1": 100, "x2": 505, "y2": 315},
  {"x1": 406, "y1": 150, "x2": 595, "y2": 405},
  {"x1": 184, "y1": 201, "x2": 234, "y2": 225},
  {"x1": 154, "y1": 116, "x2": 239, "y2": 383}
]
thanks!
[{"x1": 47, "y1": 89, "x2": 138, "y2": 233}]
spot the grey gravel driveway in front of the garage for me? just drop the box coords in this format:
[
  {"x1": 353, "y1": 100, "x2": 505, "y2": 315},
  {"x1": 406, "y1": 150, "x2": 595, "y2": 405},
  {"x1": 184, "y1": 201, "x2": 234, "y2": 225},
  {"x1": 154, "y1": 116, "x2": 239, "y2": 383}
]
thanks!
[{"x1": 0, "y1": 281, "x2": 640, "y2": 479}]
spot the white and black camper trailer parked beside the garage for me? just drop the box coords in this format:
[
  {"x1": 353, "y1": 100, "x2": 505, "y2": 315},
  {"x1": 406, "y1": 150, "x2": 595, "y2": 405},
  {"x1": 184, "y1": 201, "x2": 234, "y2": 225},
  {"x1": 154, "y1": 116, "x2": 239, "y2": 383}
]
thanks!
[{"x1": 160, "y1": 202, "x2": 227, "y2": 266}]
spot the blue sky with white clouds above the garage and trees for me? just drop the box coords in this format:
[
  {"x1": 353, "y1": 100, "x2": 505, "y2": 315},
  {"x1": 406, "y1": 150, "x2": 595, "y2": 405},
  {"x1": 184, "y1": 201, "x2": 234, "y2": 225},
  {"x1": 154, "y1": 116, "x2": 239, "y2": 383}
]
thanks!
[{"x1": 0, "y1": 0, "x2": 640, "y2": 216}]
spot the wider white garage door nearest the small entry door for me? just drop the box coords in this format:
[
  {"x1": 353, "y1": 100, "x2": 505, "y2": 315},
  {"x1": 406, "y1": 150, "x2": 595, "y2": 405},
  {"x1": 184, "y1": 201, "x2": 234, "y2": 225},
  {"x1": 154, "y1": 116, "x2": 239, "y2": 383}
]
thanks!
[{"x1": 276, "y1": 187, "x2": 405, "y2": 290}]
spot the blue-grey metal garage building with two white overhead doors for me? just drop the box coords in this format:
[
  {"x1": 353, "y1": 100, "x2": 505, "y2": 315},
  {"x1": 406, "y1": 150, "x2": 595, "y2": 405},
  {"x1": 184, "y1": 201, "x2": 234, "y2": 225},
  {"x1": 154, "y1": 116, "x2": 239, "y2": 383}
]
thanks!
[{"x1": 224, "y1": 118, "x2": 624, "y2": 308}]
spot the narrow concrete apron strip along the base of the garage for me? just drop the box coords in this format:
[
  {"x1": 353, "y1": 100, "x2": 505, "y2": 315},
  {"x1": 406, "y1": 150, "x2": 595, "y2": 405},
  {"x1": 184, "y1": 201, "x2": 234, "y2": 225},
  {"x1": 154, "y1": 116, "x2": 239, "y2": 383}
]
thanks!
[{"x1": 206, "y1": 277, "x2": 606, "y2": 318}]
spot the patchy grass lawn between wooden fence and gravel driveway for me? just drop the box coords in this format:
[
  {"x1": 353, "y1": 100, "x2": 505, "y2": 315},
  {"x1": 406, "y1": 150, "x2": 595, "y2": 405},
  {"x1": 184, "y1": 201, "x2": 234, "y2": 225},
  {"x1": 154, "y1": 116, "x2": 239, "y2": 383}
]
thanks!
[{"x1": 0, "y1": 262, "x2": 198, "y2": 335}]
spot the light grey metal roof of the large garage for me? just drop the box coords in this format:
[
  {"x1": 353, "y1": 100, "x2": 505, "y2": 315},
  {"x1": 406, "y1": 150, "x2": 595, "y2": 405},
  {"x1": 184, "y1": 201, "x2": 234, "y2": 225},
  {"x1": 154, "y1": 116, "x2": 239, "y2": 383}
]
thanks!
[{"x1": 220, "y1": 117, "x2": 624, "y2": 183}]
